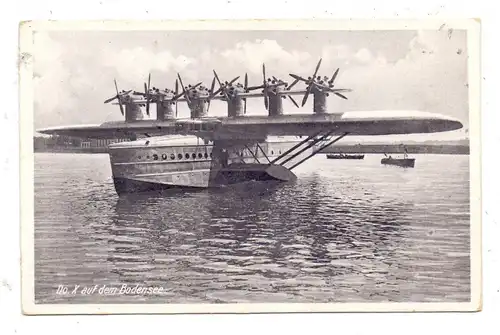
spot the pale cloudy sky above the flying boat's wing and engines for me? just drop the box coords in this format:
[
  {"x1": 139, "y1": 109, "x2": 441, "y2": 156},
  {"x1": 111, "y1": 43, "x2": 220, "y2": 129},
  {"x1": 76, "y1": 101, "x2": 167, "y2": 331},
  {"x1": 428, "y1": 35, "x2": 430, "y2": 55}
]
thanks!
[{"x1": 34, "y1": 29, "x2": 468, "y2": 139}]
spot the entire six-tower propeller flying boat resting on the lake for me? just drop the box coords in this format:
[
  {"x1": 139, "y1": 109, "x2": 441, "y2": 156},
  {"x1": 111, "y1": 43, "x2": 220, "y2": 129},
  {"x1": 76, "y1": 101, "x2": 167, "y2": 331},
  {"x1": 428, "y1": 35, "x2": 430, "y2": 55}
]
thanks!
[{"x1": 38, "y1": 59, "x2": 463, "y2": 195}]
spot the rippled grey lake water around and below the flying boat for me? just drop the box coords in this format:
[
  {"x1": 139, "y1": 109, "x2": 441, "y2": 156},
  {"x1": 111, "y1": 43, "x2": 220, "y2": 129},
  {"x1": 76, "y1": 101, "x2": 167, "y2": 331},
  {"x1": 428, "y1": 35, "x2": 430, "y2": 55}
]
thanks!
[{"x1": 35, "y1": 153, "x2": 470, "y2": 303}]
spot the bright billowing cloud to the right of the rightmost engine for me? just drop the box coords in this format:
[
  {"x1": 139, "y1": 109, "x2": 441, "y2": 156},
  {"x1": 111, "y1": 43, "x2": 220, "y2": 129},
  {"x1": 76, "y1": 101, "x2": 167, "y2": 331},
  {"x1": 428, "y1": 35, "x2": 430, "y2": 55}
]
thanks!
[{"x1": 336, "y1": 32, "x2": 467, "y2": 118}]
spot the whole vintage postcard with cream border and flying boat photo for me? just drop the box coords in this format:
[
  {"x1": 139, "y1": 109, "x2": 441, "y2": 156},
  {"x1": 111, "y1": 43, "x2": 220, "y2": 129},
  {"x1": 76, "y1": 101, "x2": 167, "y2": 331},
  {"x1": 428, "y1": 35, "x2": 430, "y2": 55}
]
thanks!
[{"x1": 19, "y1": 19, "x2": 481, "y2": 314}]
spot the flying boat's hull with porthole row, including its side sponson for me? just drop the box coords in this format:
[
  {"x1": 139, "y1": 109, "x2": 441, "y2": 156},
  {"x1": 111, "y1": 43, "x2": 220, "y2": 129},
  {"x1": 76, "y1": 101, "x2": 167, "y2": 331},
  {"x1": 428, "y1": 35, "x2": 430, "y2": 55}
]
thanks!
[{"x1": 109, "y1": 135, "x2": 312, "y2": 195}]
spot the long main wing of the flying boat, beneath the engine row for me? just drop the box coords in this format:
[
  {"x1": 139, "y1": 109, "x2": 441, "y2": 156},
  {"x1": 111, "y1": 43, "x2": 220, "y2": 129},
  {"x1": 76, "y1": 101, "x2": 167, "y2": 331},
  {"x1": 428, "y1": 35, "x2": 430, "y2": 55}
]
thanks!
[{"x1": 38, "y1": 111, "x2": 463, "y2": 140}]
